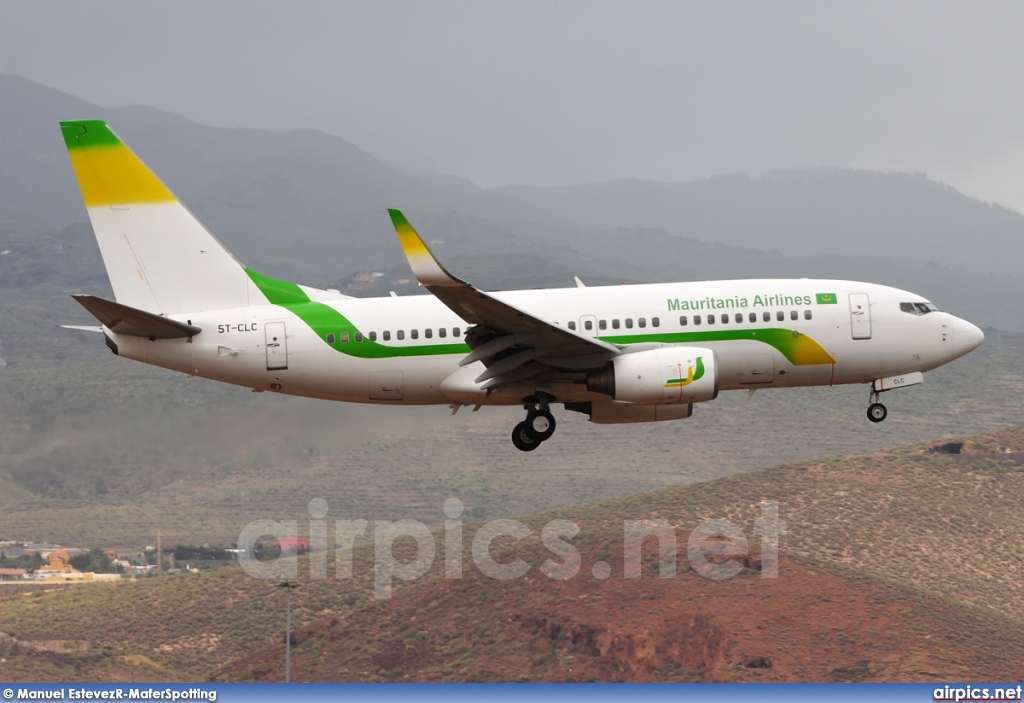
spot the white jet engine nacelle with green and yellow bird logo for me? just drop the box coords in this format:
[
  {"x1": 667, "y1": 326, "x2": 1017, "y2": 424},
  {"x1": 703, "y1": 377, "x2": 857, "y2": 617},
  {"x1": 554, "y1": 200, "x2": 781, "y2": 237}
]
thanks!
[{"x1": 587, "y1": 347, "x2": 718, "y2": 405}]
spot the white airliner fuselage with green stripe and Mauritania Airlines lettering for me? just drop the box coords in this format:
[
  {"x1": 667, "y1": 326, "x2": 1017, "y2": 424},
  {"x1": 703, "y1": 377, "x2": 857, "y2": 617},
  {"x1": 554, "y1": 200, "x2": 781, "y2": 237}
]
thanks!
[{"x1": 105, "y1": 279, "x2": 982, "y2": 404}]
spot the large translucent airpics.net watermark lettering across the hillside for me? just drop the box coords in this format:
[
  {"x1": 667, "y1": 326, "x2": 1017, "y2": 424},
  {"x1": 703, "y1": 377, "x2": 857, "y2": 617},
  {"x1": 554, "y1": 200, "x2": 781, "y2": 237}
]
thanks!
[{"x1": 238, "y1": 497, "x2": 785, "y2": 599}]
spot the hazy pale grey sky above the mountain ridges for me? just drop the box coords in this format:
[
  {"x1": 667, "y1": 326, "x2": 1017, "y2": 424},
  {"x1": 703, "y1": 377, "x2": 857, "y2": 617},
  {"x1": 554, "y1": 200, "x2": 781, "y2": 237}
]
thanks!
[{"x1": 8, "y1": 0, "x2": 1024, "y2": 212}]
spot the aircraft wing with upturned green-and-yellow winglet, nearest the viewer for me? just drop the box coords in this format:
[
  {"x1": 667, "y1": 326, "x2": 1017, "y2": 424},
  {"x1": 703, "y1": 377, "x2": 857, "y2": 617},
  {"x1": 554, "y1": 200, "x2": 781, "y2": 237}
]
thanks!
[{"x1": 388, "y1": 210, "x2": 620, "y2": 389}]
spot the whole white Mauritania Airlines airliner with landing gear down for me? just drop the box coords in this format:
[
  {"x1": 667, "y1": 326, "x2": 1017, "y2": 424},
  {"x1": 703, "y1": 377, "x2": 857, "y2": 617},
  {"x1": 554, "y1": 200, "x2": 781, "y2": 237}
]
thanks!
[{"x1": 60, "y1": 120, "x2": 984, "y2": 451}]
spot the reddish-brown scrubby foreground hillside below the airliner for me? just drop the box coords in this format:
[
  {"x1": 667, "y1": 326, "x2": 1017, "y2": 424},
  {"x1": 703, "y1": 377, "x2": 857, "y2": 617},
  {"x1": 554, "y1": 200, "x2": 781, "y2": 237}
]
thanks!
[{"x1": 0, "y1": 428, "x2": 1024, "y2": 680}]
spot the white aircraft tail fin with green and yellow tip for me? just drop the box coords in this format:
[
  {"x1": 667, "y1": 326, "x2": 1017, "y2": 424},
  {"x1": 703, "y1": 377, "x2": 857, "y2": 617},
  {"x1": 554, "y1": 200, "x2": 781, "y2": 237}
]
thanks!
[{"x1": 60, "y1": 120, "x2": 260, "y2": 315}]
